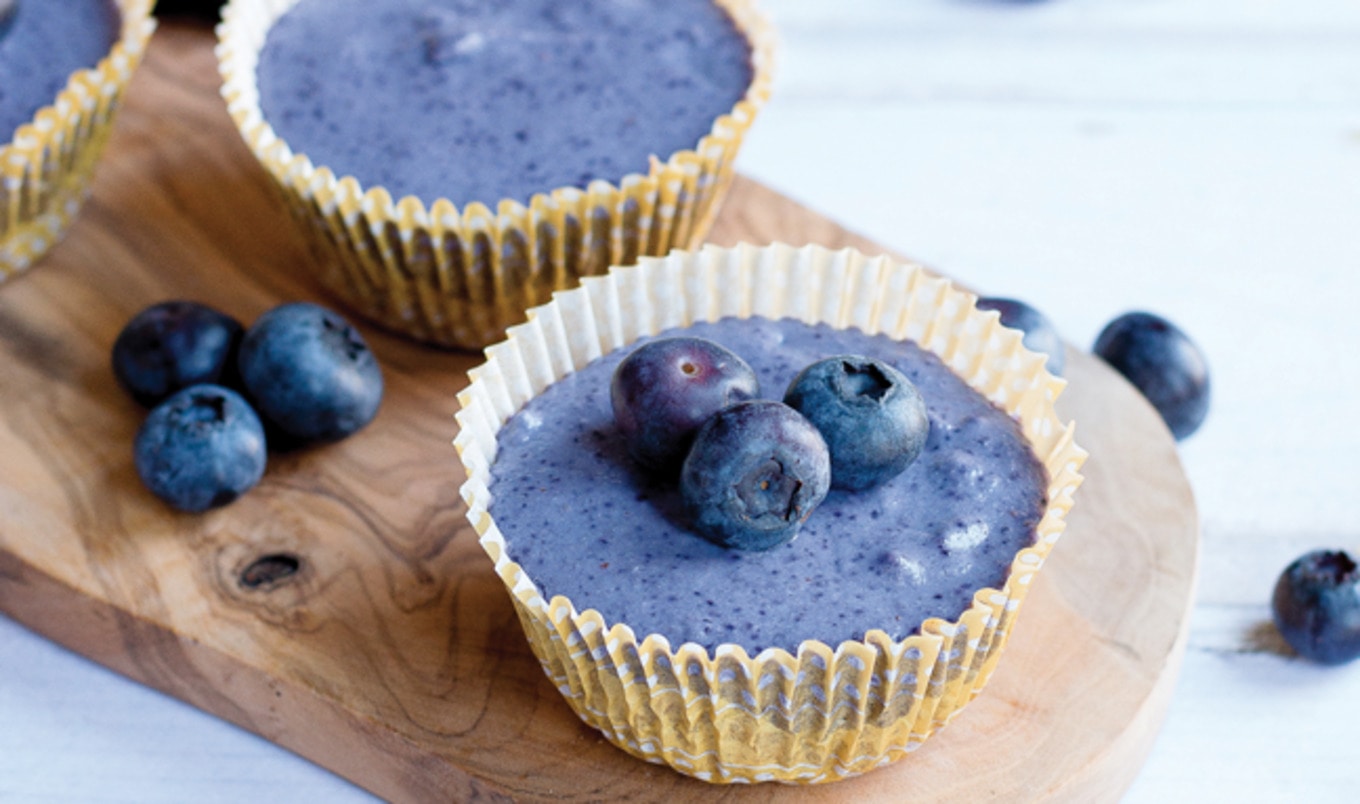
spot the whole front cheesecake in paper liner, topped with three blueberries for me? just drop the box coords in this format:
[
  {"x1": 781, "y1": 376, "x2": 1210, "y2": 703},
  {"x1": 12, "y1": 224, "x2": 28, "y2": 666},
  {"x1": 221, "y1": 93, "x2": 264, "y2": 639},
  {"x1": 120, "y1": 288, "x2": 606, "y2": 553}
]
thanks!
[{"x1": 456, "y1": 245, "x2": 1085, "y2": 782}]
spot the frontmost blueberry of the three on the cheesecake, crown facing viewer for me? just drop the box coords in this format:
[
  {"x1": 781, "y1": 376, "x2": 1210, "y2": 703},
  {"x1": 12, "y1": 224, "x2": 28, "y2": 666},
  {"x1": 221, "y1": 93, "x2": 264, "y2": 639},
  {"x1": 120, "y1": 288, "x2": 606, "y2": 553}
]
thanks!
[{"x1": 680, "y1": 400, "x2": 831, "y2": 550}]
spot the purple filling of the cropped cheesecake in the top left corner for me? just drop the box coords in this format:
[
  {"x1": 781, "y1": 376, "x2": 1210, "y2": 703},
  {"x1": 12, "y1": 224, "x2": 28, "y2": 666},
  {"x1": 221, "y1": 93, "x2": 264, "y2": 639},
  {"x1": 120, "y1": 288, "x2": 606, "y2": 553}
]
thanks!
[{"x1": 0, "y1": 0, "x2": 121, "y2": 143}]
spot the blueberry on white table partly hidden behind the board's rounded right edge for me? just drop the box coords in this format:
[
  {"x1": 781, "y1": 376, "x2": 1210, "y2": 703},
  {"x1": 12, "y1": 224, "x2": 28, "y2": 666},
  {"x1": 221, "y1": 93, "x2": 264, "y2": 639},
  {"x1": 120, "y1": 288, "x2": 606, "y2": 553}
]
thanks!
[{"x1": 1092, "y1": 313, "x2": 1209, "y2": 441}]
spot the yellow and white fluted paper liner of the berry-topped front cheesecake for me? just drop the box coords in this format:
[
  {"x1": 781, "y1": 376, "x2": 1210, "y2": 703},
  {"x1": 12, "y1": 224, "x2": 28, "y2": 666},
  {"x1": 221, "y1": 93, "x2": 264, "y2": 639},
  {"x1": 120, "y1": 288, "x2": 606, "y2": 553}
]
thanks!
[{"x1": 454, "y1": 245, "x2": 1087, "y2": 782}]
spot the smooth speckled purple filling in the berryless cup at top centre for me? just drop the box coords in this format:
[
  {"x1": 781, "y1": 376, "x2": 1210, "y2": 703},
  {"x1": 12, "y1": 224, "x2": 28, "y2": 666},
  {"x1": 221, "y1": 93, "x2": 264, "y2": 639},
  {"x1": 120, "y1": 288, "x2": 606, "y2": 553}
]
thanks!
[{"x1": 257, "y1": 0, "x2": 751, "y2": 207}]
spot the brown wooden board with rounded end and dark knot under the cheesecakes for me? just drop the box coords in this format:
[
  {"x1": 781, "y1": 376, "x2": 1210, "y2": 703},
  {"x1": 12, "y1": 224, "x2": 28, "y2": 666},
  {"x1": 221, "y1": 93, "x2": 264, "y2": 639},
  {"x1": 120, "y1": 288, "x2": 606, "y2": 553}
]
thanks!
[{"x1": 0, "y1": 23, "x2": 1198, "y2": 801}]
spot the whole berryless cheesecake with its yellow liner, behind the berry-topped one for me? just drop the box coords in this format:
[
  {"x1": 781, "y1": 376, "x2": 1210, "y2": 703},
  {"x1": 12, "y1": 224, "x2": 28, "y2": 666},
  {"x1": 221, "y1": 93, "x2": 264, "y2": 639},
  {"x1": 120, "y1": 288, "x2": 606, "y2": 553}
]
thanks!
[{"x1": 219, "y1": 0, "x2": 772, "y2": 348}]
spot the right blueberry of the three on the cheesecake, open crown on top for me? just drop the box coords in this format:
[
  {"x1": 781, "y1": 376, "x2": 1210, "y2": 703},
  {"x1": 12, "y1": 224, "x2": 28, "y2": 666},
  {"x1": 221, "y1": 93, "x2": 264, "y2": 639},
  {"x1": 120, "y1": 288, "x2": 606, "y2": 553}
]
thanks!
[{"x1": 783, "y1": 355, "x2": 930, "y2": 491}]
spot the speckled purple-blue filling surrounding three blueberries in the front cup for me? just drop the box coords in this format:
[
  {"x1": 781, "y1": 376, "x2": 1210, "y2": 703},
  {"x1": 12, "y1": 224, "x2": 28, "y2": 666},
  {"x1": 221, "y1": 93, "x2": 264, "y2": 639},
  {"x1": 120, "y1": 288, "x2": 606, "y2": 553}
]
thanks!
[{"x1": 491, "y1": 320, "x2": 1047, "y2": 654}]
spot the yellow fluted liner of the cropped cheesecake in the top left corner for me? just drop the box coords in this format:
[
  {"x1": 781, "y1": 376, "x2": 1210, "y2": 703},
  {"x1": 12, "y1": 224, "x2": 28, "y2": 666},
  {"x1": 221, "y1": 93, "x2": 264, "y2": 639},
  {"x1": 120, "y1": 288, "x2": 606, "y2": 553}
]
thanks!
[{"x1": 0, "y1": 0, "x2": 156, "y2": 282}]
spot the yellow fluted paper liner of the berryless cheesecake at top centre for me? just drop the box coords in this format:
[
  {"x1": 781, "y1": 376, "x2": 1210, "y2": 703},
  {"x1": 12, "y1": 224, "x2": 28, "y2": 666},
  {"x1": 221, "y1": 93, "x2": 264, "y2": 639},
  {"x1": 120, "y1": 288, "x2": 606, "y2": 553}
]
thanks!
[{"x1": 218, "y1": 0, "x2": 775, "y2": 348}]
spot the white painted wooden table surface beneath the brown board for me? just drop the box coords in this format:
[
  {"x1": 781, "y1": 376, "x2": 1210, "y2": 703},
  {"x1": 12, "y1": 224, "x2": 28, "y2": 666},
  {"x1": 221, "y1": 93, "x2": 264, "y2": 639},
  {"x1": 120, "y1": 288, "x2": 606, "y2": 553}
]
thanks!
[{"x1": 0, "y1": 0, "x2": 1360, "y2": 803}]
